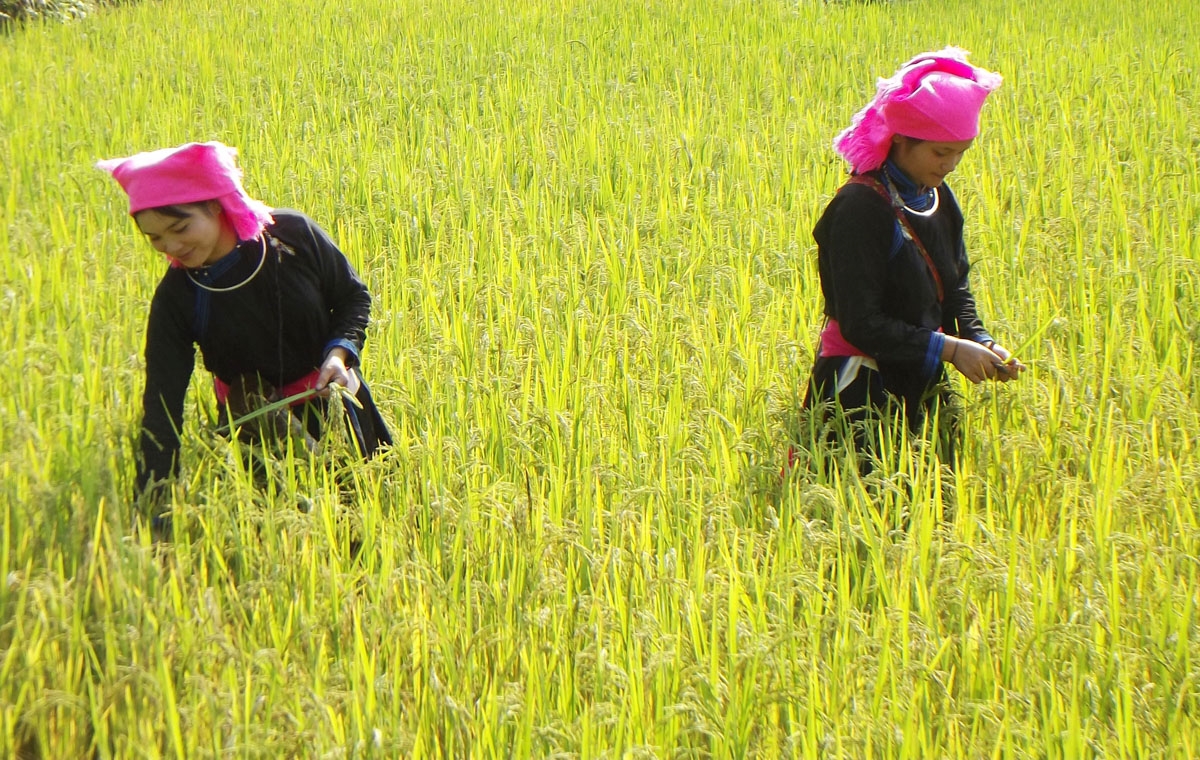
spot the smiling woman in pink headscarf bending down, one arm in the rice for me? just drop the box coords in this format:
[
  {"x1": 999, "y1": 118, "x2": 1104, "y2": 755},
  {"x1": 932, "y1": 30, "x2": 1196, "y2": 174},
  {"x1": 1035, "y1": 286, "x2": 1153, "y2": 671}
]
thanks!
[{"x1": 97, "y1": 142, "x2": 391, "y2": 509}]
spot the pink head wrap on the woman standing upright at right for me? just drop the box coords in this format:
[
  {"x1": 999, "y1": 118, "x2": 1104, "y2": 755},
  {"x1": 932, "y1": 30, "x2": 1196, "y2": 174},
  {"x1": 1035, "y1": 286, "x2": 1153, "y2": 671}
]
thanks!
[{"x1": 833, "y1": 47, "x2": 1001, "y2": 174}]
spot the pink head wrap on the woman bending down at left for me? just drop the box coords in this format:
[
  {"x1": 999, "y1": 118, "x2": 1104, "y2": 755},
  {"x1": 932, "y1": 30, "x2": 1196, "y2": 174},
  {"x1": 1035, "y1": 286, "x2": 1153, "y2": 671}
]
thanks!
[{"x1": 96, "y1": 142, "x2": 272, "y2": 240}]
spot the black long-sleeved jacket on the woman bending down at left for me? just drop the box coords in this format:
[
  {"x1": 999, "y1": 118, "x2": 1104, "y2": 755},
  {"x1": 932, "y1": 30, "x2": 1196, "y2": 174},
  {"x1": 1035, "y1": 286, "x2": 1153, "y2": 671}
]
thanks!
[{"x1": 137, "y1": 209, "x2": 371, "y2": 492}]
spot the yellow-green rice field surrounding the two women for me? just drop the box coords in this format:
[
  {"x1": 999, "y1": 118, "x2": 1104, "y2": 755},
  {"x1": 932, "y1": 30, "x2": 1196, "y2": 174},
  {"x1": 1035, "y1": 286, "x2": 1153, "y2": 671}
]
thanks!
[{"x1": 0, "y1": 0, "x2": 1200, "y2": 759}]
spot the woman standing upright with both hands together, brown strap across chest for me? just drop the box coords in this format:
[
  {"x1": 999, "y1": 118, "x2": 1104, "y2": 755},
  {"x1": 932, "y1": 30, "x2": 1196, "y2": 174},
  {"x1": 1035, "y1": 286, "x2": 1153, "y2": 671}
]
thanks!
[{"x1": 804, "y1": 48, "x2": 1025, "y2": 467}]
